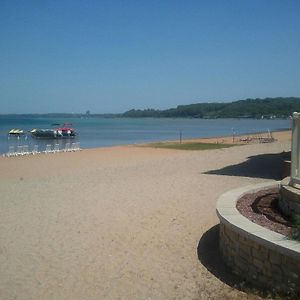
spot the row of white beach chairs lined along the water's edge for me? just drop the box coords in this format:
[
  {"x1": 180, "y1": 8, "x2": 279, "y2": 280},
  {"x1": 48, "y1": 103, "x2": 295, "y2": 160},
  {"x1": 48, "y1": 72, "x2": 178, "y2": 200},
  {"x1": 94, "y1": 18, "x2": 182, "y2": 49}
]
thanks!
[{"x1": 3, "y1": 142, "x2": 81, "y2": 157}]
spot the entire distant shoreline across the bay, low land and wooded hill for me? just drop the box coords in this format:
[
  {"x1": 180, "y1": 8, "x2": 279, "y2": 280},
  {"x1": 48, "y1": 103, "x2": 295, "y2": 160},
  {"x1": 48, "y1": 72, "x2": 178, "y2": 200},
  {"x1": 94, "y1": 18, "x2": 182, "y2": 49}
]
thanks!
[{"x1": 0, "y1": 97, "x2": 300, "y2": 120}]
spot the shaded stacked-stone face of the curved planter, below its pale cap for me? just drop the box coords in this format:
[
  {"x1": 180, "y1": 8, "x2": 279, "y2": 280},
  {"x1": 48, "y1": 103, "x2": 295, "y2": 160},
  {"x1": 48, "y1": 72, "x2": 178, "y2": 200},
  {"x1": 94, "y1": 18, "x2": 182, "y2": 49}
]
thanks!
[{"x1": 220, "y1": 224, "x2": 300, "y2": 293}]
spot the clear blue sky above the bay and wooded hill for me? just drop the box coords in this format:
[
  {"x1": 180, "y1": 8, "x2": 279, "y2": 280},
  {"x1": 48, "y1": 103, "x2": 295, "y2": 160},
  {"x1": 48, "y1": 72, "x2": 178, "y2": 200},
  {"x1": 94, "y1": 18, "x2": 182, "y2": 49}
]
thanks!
[{"x1": 0, "y1": 0, "x2": 300, "y2": 113}]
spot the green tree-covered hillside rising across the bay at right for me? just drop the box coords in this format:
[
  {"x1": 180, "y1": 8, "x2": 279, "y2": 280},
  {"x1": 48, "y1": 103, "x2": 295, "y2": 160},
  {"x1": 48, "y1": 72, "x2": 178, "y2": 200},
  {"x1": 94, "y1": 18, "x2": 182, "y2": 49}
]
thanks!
[{"x1": 123, "y1": 97, "x2": 300, "y2": 118}]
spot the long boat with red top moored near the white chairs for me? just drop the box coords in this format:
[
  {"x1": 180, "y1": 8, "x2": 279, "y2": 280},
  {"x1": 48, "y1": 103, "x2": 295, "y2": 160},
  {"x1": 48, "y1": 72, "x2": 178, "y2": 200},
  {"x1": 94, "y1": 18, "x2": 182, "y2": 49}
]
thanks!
[{"x1": 30, "y1": 124, "x2": 77, "y2": 139}]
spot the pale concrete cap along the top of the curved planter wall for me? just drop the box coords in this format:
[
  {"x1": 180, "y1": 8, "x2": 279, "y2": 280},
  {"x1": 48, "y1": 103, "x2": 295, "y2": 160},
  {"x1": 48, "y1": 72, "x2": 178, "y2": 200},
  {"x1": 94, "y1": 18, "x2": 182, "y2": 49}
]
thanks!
[{"x1": 216, "y1": 181, "x2": 300, "y2": 260}]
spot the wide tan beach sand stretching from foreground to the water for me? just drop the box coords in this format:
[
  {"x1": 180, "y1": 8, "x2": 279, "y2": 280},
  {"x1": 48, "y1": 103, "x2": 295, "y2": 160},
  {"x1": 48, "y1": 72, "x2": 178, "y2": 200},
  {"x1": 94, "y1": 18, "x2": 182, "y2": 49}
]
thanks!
[{"x1": 0, "y1": 131, "x2": 291, "y2": 299}]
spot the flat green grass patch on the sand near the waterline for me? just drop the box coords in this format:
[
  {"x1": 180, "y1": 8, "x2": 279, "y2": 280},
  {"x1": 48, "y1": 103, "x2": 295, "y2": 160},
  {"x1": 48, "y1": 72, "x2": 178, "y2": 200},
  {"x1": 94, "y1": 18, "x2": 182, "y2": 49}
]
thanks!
[{"x1": 149, "y1": 142, "x2": 236, "y2": 150}]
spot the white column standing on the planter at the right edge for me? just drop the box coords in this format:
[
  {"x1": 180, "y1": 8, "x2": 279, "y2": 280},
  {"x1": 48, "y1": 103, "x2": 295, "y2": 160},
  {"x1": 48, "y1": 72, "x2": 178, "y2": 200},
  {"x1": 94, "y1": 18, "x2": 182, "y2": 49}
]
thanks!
[{"x1": 290, "y1": 112, "x2": 300, "y2": 189}]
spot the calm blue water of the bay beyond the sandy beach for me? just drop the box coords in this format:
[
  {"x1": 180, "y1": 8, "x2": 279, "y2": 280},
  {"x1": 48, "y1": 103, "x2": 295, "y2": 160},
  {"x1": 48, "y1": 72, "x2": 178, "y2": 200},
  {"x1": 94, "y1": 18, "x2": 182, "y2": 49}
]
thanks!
[{"x1": 0, "y1": 116, "x2": 291, "y2": 153}]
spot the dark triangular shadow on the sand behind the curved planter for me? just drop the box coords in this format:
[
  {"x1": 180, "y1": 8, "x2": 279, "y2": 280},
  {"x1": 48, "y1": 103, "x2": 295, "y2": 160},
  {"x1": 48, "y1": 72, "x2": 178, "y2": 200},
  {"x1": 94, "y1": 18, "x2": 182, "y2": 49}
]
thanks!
[{"x1": 204, "y1": 153, "x2": 284, "y2": 180}]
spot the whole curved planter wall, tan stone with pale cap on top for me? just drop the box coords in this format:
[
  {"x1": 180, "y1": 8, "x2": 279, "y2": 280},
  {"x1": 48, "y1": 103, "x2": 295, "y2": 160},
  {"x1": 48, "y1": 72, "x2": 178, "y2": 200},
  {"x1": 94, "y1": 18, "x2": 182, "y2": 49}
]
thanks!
[{"x1": 217, "y1": 183, "x2": 300, "y2": 294}]
